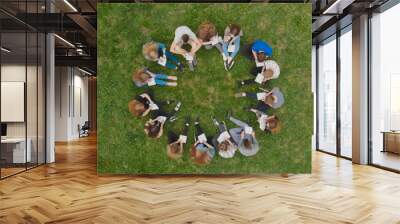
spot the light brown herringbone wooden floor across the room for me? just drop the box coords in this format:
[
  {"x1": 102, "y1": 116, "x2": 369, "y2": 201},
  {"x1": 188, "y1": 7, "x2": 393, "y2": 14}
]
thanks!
[{"x1": 0, "y1": 137, "x2": 400, "y2": 224}]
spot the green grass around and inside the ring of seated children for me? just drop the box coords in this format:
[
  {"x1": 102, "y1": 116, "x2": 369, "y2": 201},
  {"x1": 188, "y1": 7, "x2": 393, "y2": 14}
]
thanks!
[{"x1": 97, "y1": 4, "x2": 313, "y2": 174}]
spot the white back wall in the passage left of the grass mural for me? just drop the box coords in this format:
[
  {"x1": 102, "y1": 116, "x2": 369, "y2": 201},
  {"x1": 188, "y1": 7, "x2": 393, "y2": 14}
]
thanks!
[{"x1": 55, "y1": 67, "x2": 88, "y2": 141}]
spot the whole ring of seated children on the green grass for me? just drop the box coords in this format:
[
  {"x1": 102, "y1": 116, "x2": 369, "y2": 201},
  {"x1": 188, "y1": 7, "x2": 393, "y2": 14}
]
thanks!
[{"x1": 129, "y1": 21, "x2": 284, "y2": 164}]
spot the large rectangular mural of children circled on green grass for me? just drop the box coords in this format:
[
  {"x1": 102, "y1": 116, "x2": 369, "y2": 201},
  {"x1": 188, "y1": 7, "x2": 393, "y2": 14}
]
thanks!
[{"x1": 98, "y1": 3, "x2": 313, "y2": 174}]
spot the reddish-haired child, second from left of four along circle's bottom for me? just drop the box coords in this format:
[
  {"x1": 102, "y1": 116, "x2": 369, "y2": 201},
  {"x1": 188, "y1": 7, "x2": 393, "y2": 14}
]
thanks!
[{"x1": 190, "y1": 118, "x2": 215, "y2": 165}]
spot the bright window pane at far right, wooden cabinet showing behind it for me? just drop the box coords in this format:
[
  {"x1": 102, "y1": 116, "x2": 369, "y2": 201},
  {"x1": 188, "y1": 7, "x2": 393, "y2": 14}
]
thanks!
[{"x1": 371, "y1": 4, "x2": 400, "y2": 170}]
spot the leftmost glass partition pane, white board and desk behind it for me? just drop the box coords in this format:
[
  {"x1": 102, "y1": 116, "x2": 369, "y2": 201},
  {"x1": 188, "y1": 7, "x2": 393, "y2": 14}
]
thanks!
[{"x1": 0, "y1": 32, "x2": 27, "y2": 178}]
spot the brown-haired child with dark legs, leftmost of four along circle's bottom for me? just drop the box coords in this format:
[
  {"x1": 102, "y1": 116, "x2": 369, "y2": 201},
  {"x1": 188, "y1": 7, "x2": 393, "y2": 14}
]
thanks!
[{"x1": 167, "y1": 118, "x2": 190, "y2": 159}]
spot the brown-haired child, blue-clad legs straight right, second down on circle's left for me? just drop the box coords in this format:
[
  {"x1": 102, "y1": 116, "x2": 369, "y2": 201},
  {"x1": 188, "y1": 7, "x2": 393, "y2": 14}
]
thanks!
[{"x1": 132, "y1": 68, "x2": 178, "y2": 87}]
